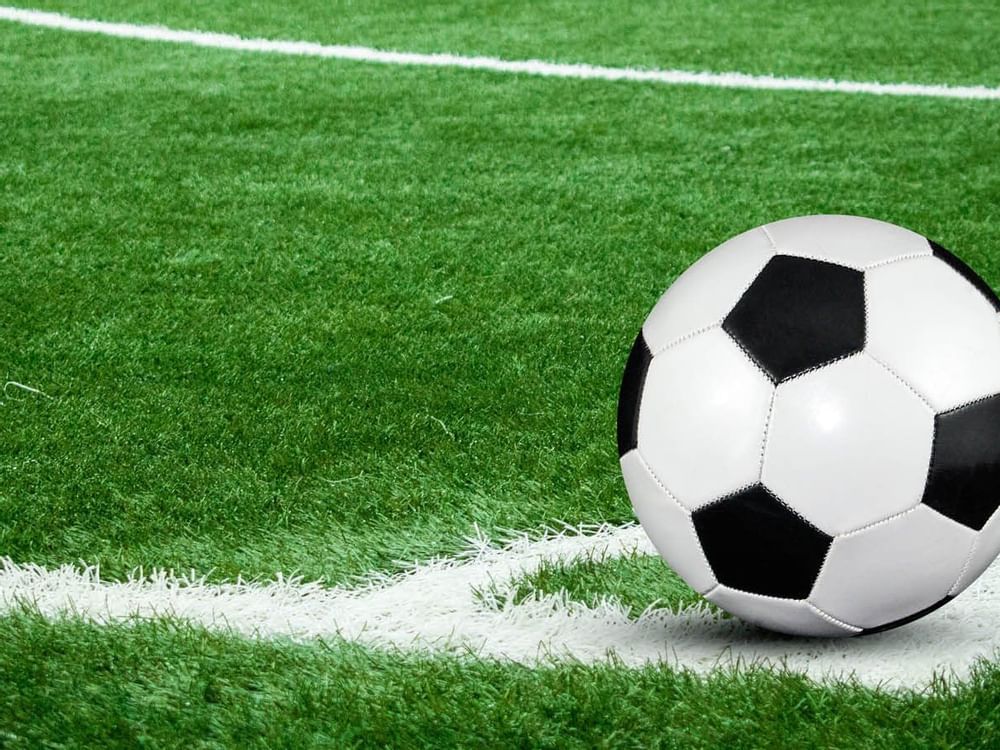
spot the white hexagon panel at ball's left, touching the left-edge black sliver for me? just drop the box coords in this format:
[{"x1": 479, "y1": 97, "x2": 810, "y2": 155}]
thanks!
[{"x1": 638, "y1": 328, "x2": 774, "y2": 510}]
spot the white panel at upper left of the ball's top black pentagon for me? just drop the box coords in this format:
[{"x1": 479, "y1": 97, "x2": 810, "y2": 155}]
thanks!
[{"x1": 642, "y1": 229, "x2": 774, "y2": 355}]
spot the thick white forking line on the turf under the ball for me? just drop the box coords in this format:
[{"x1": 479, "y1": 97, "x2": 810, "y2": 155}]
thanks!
[{"x1": 0, "y1": 525, "x2": 1000, "y2": 689}]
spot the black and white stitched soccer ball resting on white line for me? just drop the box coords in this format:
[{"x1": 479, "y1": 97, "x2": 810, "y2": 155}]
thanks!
[{"x1": 618, "y1": 216, "x2": 1000, "y2": 636}]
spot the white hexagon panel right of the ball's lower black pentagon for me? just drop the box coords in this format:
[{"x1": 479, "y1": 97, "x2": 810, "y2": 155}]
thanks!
[{"x1": 809, "y1": 505, "x2": 976, "y2": 631}]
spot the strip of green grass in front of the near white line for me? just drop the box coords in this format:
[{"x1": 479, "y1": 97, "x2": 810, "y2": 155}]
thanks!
[{"x1": 0, "y1": 615, "x2": 1000, "y2": 750}]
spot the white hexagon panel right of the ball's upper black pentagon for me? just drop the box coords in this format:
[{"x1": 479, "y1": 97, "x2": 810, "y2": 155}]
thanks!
[{"x1": 865, "y1": 256, "x2": 1000, "y2": 412}]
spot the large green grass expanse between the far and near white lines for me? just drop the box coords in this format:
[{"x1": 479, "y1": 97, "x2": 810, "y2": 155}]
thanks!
[{"x1": 0, "y1": 25, "x2": 1000, "y2": 581}]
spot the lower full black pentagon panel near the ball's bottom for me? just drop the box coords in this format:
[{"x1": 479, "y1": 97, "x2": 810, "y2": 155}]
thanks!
[{"x1": 692, "y1": 484, "x2": 833, "y2": 599}]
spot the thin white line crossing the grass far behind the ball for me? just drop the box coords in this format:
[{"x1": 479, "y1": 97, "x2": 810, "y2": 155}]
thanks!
[{"x1": 0, "y1": 6, "x2": 1000, "y2": 100}]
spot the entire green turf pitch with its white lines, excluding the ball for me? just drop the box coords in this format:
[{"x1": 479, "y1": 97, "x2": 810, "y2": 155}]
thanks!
[{"x1": 0, "y1": 0, "x2": 1000, "y2": 748}]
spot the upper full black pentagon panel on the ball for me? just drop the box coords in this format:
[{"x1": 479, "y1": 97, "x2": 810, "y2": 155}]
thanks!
[{"x1": 722, "y1": 255, "x2": 865, "y2": 382}]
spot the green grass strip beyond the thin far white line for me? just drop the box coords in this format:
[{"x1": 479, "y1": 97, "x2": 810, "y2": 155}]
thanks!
[{"x1": 22, "y1": 0, "x2": 1000, "y2": 86}]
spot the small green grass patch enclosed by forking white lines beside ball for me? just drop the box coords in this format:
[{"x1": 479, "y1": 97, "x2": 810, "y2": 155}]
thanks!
[{"x1": 494, "y1": 554, "x2": 721, "y2": 618}]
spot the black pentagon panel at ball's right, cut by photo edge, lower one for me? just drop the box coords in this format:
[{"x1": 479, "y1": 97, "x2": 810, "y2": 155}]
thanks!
[{"x1": 924, "y1": 395, "x2": 1000, "y2": 530}]
